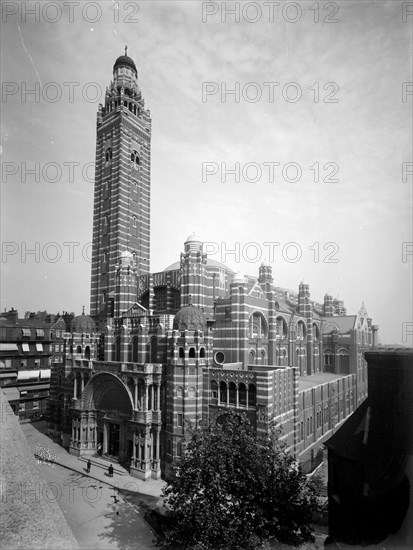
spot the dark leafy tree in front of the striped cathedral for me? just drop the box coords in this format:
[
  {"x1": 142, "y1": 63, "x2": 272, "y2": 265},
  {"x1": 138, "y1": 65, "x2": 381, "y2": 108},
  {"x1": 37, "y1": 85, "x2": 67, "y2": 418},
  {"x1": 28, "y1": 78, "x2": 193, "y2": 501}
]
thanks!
[{"x1": 162, "y1": 411, "x2": 317, "y2": 550}]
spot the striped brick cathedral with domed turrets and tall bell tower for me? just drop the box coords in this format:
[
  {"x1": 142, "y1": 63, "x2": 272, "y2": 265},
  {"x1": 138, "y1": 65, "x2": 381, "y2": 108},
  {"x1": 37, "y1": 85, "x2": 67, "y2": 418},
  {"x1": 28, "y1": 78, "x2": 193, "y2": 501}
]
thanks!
[{"x1": 48, "y1": 50, "x2": 378, "y2": 480}]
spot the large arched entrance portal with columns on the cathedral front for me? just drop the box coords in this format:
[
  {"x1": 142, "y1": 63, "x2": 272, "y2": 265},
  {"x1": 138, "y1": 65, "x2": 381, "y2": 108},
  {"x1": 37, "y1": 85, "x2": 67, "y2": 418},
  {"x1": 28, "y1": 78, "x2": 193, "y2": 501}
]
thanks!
[{"x1": 71, "y1": 372, "x2": 133, "y2": 462}]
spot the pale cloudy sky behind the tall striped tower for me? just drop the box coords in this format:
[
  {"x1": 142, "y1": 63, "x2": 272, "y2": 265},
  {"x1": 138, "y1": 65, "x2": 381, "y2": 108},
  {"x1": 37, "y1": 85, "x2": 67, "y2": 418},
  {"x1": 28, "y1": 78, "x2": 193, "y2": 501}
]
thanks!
[{"x1": 0, "y1": 0, "x2": 413, "y2": 346}]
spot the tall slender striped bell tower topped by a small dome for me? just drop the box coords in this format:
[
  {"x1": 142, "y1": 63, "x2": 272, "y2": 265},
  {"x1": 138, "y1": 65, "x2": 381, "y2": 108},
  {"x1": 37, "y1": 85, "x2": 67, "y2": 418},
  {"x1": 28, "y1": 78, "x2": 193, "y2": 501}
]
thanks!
[{"x1": 90, "y1": 48, "x2": 151, "y2": 319}]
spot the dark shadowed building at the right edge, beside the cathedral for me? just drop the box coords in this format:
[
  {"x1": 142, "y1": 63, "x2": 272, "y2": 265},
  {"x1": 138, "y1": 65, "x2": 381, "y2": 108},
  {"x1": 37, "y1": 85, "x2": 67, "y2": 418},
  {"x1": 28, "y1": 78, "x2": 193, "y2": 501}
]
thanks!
[{"x1": 326, "y1": 348, "x2": 413, "y2": 549}]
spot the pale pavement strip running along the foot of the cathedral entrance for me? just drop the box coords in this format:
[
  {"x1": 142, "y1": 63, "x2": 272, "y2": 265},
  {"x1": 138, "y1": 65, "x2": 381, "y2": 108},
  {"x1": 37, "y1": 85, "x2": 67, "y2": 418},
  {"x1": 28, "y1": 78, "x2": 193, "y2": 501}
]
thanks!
[{"x1": 21, "y1": 421, "x2": 165, "y2": 508}]
